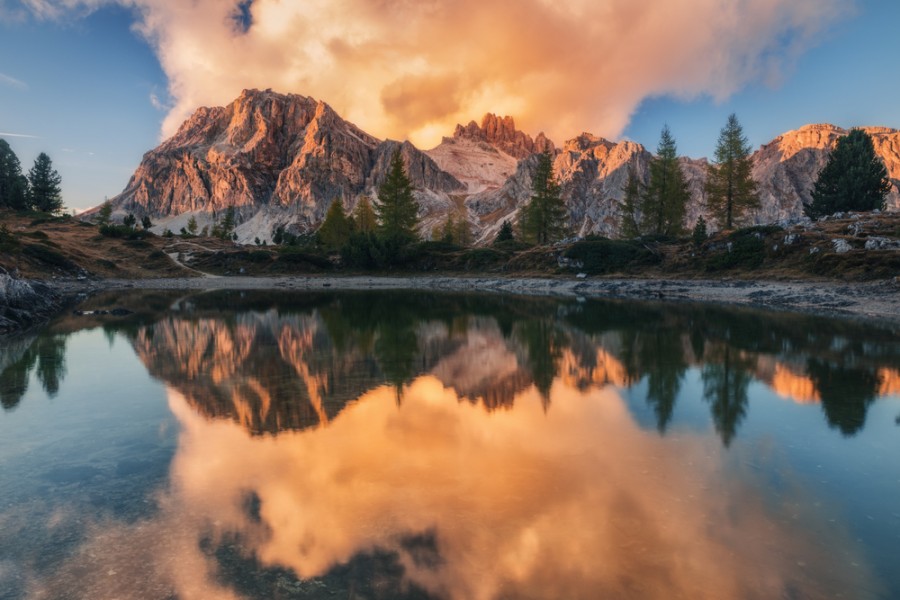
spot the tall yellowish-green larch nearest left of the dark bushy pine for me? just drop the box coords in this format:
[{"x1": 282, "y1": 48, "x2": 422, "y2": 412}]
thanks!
[{"x1": 706, "y1": 113, "x2": 759, "y2": 229}]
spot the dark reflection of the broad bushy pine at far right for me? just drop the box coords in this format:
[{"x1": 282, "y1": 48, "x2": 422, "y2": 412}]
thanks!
[{"x1": 807, "y1": 358, "x2": 879, "y2": 436}]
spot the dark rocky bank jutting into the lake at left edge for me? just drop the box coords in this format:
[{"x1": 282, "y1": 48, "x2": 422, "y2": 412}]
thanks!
[{"x1": 0, "y1": 267, "x2": 63, "y2": 335}]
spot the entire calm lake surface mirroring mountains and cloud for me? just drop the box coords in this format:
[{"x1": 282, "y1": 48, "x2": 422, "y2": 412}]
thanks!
[{"x1": 0, "y1": 292, "x2": 900, "y2": 600}]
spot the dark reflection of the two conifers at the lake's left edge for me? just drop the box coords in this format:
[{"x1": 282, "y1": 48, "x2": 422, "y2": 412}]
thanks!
[{"x1": 0, "y1": 335, "x2": 66, "y2": 410}]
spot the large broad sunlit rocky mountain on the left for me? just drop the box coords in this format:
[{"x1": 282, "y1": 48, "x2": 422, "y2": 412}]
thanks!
[{"x1": 112, "y1": 90, "x2": 465, "y2": 241}]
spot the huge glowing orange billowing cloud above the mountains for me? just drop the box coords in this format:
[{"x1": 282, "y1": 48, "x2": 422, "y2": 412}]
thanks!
[{"x1": 28, "y1": 0, "x2": 850, "y2": 146}]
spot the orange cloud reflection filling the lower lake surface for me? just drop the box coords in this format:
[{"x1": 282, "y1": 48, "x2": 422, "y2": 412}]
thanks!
[{"x1": 26, "y1": 376, "x2": 873, "y2": 599}]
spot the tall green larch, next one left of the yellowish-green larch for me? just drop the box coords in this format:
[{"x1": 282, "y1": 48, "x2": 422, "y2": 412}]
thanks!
[{"x1": 641, "y1": 125, "x2": 691, "y2": 235}]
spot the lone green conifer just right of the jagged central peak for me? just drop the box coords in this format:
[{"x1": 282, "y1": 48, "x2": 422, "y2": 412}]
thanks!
[{"x1": 521, "y1": 152, "x2": 568, "y2": 244}]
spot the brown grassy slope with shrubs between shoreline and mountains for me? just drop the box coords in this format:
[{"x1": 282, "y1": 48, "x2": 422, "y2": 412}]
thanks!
[{"x1": 0, "y1": 213, "x2": 900, "y2": 281}]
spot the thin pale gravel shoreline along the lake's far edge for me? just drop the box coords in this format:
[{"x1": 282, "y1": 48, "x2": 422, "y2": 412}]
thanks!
[{"x1": 52, "y1": 275, "x2": 900, "y2": 324}]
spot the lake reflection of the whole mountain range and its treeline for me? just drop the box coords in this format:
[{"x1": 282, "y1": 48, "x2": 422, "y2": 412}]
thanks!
[{"x1": 0, "y1": 292, "x2": 900, "y2": 445}]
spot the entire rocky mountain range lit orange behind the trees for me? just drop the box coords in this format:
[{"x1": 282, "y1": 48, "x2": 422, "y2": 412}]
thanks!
[{"x1": 111, "y1": 90, "x2": 900, "y2": 243}]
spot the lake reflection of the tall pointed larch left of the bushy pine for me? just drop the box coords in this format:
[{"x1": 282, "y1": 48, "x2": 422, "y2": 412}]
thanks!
[{"x1": 700, "y1": 345, "x2": 753, "y2": 447}]
